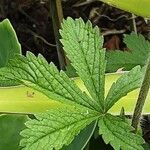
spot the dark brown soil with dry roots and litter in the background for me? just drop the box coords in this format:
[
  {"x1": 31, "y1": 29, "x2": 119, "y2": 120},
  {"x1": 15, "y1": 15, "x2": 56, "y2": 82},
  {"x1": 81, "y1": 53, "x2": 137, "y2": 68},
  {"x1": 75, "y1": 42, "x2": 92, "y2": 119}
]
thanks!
[{"x1": 0, "y1": 0, "x2": 150, "y2": 65}]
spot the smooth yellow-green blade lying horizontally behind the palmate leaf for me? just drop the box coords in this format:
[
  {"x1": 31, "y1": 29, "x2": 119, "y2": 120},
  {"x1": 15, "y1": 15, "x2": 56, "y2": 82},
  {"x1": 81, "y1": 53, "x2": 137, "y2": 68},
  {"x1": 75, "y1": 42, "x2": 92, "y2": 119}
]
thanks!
[{"x1": 0, "y1": 73, "x2": 150, "y2": 115}]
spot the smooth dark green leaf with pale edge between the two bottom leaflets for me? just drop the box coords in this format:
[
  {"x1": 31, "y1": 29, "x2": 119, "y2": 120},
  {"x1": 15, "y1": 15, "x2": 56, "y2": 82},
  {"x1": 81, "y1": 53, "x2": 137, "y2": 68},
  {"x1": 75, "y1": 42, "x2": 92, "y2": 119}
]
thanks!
[{"x1": 62, "y1": 121, "x2": 97, "y2": 150}]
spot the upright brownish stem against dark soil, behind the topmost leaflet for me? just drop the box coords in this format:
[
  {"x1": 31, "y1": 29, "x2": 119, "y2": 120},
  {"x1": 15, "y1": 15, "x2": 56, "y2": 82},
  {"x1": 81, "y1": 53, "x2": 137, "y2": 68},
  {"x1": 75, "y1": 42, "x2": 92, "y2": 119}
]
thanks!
[{"x1": 50, "y1": 0, "x2": 66, "y2": 70}]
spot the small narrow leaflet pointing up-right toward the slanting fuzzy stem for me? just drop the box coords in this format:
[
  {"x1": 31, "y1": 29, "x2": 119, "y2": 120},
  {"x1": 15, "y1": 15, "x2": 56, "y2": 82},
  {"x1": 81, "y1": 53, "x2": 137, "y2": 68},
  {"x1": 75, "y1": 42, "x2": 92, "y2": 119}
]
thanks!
[{"x1": 105, "y1": 66, "x2": 143, "y2": 112}]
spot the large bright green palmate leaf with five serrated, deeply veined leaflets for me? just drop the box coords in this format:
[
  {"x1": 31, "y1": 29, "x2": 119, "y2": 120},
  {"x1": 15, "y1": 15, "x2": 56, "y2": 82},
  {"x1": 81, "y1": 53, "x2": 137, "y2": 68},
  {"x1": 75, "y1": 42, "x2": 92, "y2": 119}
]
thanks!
[{"x1": 0, "y1": 18, "x2": 143, "y2": 150}]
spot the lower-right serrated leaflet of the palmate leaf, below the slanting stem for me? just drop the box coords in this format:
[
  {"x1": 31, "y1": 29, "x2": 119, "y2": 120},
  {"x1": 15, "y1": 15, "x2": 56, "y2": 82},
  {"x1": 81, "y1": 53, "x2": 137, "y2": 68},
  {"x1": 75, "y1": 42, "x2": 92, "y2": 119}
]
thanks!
[{"x1": 98, "y1": 114, "x2": 144, "y2": 150}]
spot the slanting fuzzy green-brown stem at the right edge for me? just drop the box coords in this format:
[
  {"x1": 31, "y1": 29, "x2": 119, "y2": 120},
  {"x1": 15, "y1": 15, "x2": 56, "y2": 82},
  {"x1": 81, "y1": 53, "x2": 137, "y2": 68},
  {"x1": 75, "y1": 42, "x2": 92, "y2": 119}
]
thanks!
[{"x1": 132, "y1": 57, "x2": 150, "y2": 132}]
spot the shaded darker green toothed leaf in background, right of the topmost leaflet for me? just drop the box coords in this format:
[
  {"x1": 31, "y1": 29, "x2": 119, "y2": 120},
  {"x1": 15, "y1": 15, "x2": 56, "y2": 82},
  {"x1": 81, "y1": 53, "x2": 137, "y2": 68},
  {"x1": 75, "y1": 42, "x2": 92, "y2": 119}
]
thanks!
[{"x1": 106, "y1": 33, "x2": 150, "y2": 72}]
